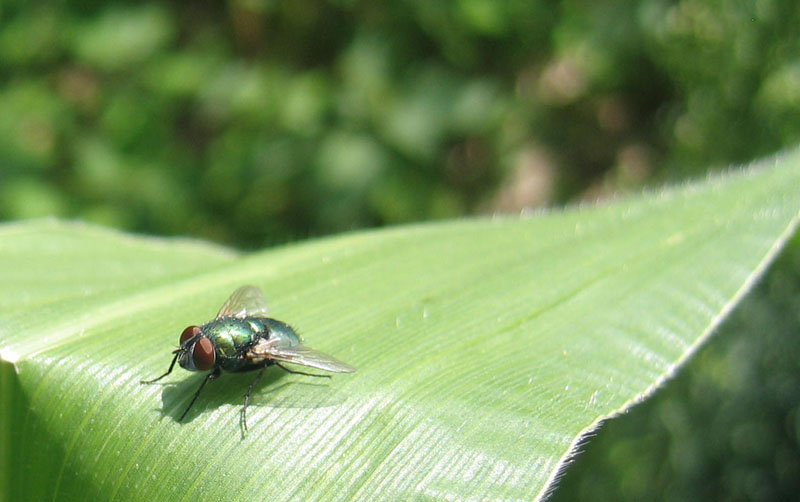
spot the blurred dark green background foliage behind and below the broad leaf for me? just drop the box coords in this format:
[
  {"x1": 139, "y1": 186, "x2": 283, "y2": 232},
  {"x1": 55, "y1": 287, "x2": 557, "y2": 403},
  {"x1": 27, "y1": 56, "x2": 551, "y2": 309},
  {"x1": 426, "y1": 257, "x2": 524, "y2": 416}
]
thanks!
[{"x1": 0, "y1": 0, "x2": 800, "y2": 500}]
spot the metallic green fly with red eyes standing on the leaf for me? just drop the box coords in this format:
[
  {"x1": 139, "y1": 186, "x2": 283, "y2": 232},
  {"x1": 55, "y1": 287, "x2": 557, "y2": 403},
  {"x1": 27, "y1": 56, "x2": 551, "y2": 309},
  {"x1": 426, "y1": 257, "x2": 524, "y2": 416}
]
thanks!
[{"x1": 141, "y1": 286, "x2": 356, "y2": 431}]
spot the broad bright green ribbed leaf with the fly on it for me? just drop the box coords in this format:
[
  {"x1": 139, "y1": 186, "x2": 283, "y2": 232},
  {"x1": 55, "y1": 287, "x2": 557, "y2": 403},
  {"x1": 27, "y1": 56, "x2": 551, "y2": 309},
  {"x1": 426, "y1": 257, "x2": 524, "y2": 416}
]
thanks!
[{"x1": 0, "y1": 151, "x2": 800, "y2": 500}]
